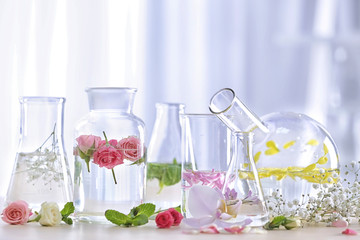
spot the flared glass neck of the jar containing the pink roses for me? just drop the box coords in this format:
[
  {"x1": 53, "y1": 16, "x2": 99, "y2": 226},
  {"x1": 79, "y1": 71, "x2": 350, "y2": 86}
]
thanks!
[{"x1": 86, "y1": 88, "x2": 137, "y2": 113}]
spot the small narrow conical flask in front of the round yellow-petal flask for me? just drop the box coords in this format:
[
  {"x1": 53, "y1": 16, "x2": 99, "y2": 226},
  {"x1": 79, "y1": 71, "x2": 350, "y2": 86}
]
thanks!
[{"x1": 220, "y1": 132, "x2": 269, "y2": 227}]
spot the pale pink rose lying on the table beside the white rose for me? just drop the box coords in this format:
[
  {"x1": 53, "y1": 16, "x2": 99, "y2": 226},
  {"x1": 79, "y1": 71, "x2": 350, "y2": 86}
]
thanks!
[{"x1": 1, "y1": 200, "x2": 31, "y2": 224}]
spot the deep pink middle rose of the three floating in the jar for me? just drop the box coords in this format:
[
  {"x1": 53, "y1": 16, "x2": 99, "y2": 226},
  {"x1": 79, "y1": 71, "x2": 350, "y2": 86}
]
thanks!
[{"x1": 94, "y1": 145, "x2": 124, "y2": 169}]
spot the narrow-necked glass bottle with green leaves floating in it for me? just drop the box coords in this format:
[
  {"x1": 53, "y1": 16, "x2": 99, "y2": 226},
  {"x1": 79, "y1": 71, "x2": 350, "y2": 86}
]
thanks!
[{"x1": 146, "y1": 103, "x2": 184, "y2": 209}]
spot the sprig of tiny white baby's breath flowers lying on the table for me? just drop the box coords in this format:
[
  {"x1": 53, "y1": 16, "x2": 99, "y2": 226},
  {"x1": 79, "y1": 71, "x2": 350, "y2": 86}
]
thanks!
[{"x1": 267, "y1": 161, "x2": 360, "y2": 224}]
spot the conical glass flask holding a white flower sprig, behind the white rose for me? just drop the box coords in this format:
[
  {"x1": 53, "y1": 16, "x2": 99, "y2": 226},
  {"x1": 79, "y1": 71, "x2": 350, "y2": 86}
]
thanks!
[{"x1": 6, "y1": 97, "x2": 72, "y2": 209}]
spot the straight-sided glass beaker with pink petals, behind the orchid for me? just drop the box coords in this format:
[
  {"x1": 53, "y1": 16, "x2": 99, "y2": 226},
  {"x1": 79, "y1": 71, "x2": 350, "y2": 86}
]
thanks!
[{"x1": 181, "y1": 114, "x2": 231, "y2": 218}]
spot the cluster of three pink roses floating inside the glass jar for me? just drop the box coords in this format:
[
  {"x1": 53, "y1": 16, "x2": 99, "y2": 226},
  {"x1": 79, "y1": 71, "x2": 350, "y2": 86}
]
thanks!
[{"x1": 74, "y1": 135, "x2": 142, "y2": 172}]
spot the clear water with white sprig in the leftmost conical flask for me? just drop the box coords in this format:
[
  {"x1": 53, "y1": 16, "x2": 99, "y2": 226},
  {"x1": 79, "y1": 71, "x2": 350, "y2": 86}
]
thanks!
[{"x1": 6, "y1": 151, "x2": 71, "y2": 210}]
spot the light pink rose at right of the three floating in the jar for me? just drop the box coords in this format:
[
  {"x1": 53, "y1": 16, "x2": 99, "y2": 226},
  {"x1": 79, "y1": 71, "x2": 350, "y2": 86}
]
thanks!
[{"x1": 117, "y1": 136, "x2": 141, "y2": 162}]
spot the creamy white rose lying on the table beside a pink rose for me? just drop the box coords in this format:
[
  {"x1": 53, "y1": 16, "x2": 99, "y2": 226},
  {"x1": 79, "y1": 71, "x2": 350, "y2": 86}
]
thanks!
[{"x1": 39, "y1": 202, "x2": 62, "y2": 226}]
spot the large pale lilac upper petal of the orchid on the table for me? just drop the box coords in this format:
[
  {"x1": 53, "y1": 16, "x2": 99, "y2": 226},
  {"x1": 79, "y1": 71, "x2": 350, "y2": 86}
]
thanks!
[{"x1": 188, "y1": 185, "x2": 221, "y2": 218}]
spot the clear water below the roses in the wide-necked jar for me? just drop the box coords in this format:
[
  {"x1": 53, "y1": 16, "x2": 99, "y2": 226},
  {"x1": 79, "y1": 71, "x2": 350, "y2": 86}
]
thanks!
[{"x1": 74, "y1": 157, "x2": 145, "y2": 222}]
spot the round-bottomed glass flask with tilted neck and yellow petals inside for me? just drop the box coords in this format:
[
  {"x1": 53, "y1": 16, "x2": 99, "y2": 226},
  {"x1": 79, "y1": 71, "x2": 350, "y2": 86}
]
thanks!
[{"x1": 209, "y1": 88, "x2": 339, "y2": 201}]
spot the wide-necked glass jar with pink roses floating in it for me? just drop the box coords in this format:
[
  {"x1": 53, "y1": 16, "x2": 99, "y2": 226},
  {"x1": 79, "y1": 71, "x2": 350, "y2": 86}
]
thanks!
[{"x1": 74, "y1": 88, "x2": 146, "y2": 222}]
